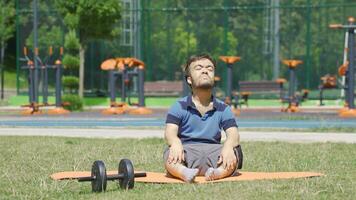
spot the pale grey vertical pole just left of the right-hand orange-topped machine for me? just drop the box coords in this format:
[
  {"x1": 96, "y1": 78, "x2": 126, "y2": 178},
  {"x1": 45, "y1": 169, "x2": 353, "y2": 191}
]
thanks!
[{"x1": 273, "y1": 0, "x2": 280, "y2": 80}]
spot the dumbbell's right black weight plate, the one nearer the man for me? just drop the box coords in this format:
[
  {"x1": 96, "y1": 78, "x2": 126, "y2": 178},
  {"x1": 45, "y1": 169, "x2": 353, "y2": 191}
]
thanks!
[{"x1": 118, "y1": 159, "x2": 135, "y2": 190}]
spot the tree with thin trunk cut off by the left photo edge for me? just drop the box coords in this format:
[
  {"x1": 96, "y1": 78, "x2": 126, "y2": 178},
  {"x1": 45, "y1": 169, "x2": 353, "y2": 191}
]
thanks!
[{"x1": 0, "y1": 0, "x2": 15, "y2": 99}]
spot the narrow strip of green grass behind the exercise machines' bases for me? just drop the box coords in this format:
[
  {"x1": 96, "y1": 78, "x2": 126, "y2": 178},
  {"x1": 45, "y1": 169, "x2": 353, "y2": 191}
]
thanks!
[{"x1": 9, "y1": 95, "x2": 343, "y2": 107}]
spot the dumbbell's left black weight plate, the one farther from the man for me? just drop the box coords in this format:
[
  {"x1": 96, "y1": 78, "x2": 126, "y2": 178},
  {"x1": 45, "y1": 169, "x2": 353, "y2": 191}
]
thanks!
[{"x1": 91, "y1": 160, "x2": 107, "y2": 192}]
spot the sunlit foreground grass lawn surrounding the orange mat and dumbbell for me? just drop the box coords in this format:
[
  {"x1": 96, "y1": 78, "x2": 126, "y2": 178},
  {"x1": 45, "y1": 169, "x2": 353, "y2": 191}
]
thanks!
[{"x1": 0, "y1": 137, "x2": 356, "y2": 199}]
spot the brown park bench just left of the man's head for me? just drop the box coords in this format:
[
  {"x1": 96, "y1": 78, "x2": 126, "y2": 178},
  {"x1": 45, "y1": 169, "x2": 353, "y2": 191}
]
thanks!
[{"x1": 144, "y1": 81, "x2": 183, "y2": 96}]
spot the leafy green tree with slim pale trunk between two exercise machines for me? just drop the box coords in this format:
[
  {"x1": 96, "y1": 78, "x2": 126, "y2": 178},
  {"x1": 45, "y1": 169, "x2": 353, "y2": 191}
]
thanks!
[{"x1": 55, "y1": 0, "x2": 121, "y2": 97}]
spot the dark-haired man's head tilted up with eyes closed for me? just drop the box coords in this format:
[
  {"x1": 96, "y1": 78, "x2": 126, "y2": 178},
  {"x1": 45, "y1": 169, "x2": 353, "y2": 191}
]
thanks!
[{"x1": 187, "y1": 58, "x2": 215, "y2": 89}]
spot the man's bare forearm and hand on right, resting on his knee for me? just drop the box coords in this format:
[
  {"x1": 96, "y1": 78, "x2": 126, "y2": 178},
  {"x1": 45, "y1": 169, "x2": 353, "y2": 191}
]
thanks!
[{"x1": 219, "y1": 127, "x2": 240, "y2": 169}]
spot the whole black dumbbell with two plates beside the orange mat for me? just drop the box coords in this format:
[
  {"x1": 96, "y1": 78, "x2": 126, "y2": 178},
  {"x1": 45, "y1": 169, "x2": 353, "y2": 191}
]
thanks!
[{"x1": 78, "y1": 159, "x2": 146, "y2": 192}]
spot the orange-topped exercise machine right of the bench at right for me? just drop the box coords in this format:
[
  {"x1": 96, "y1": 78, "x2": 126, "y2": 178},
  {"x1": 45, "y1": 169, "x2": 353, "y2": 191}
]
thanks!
[{"x1": 281, "y1": 60, "x2": 309, "y2": 112}]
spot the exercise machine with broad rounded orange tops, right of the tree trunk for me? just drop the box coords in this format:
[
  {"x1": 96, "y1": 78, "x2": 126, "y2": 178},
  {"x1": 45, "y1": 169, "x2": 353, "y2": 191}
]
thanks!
[{"x1": 101, "y1": 58, "x2": 152, "y2": 115}]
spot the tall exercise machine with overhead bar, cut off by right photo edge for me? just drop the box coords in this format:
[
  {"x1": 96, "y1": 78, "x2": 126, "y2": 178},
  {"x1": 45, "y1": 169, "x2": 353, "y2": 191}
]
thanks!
[{"x1": 329, "y1": 17, "x2": 356, "y2": 117}]
